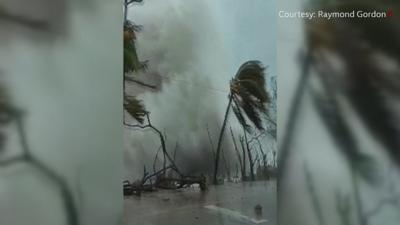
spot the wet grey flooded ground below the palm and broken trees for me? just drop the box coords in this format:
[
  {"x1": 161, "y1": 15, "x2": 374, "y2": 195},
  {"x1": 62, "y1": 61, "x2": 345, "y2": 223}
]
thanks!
[{"x1": 124, "y1": 181, "x2": 277, "y2": 225}]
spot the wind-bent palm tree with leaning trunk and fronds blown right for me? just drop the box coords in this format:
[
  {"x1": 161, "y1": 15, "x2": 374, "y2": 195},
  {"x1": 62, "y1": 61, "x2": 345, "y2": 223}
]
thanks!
[{"x1": 214, "y1": 60, "x2": 270, "y2": 184}]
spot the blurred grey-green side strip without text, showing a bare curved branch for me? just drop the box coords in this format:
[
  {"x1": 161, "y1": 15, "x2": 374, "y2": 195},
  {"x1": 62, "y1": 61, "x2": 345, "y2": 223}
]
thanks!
[{"x1": 0, "y1": 0, "x2": 123, "y2": 225}]
